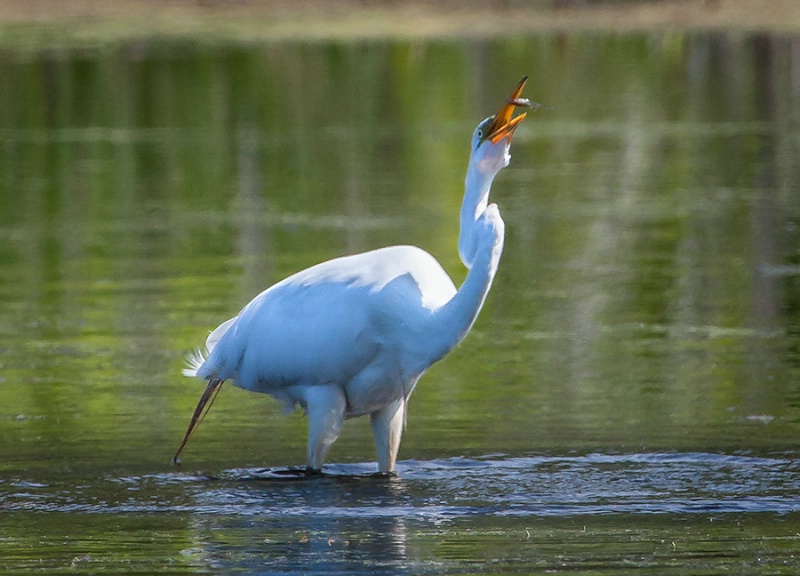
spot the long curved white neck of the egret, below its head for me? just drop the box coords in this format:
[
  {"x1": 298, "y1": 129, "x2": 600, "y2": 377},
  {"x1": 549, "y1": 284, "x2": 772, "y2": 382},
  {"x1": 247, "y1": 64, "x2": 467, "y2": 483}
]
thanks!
[{"x1": 430, "y1": 164, "x2": 505, "y2": 363}]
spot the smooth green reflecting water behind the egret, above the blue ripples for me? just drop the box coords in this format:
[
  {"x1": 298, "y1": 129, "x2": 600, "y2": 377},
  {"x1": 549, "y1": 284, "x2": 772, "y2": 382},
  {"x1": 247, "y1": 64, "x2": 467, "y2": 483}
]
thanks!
[{"x1": 0, "y1": 33, "x2": 800, "y2": 468}]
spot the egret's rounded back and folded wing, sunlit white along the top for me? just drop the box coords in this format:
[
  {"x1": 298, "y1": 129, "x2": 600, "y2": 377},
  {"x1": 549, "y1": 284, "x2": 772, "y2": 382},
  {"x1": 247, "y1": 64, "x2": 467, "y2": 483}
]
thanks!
[{"x1": 189, "y1": 246, "x2": 456, "y2": 393}]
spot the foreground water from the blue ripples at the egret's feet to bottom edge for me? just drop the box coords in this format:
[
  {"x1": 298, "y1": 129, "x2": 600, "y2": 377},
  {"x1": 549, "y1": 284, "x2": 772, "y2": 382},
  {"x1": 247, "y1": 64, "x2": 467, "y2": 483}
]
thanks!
[{"x1": 4, "y1": 453, "x2": 800, "y2": 574}]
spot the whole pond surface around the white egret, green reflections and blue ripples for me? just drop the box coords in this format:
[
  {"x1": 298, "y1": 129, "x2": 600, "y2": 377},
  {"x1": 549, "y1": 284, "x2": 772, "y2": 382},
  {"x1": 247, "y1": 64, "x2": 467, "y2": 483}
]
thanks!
[{"x1": 0, "y1": 32, "x2": 800, "y2": 574}]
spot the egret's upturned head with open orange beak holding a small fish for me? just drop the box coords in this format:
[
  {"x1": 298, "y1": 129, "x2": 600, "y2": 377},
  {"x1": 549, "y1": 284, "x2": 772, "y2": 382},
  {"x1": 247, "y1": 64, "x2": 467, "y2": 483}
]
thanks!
[{"x1": 470, "y1": 76, "x2": 532, "y2": 174}]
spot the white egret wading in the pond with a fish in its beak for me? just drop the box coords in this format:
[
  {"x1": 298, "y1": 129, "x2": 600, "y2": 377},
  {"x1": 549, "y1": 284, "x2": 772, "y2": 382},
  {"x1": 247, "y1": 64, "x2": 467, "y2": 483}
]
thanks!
[{"x1": 173, "y1": 78, "x2": 528, "y2": 473}]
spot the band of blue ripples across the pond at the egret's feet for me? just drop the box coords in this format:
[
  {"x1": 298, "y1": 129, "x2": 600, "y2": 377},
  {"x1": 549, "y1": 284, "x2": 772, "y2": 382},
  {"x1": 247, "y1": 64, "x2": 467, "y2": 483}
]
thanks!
[{"x1": 0, "y1": 453, "x2": 800, "y2": 521}]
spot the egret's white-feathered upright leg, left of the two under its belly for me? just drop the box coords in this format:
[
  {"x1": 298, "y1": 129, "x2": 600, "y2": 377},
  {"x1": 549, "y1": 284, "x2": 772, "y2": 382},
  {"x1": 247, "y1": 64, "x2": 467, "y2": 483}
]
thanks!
[{"x1": 305, "y1": 384, "x2": 347, "y2": 473}]
